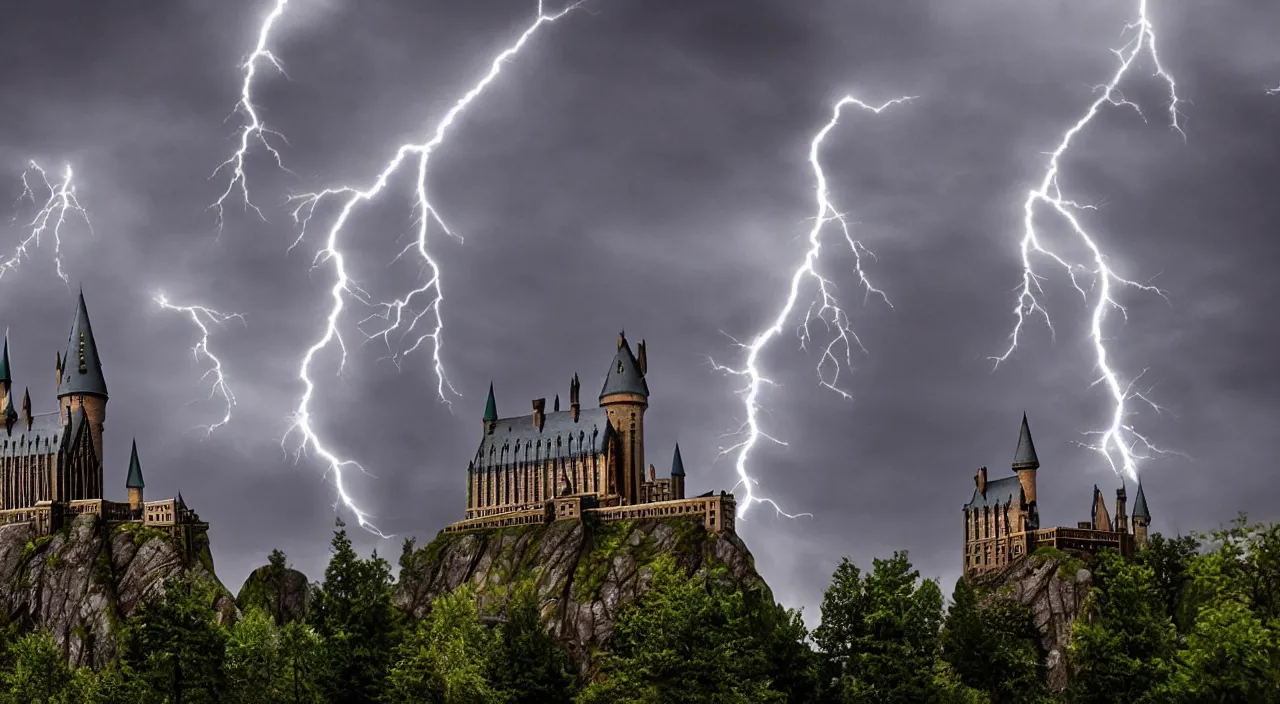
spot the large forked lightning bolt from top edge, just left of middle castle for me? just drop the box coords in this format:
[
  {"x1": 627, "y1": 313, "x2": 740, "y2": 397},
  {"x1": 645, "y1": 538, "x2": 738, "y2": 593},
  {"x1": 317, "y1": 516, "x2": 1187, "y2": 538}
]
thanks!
[{"x1": 282, "y1": 1, "x2": 580, "y2": 538}]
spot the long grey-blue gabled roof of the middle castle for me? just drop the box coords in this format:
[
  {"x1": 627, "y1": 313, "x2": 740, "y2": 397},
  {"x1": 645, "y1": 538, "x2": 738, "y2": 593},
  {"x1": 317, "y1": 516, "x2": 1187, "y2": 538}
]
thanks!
[{"x1": 472, "y1": 408, "x2": 613, "y2": 471}]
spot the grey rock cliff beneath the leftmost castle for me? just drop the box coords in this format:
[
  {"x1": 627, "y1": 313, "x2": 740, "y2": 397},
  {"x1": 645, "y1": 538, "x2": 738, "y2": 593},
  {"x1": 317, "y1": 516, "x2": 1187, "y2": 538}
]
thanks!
[{"x1": 0, "y1": 516, "x2": 238, "y2": 667}]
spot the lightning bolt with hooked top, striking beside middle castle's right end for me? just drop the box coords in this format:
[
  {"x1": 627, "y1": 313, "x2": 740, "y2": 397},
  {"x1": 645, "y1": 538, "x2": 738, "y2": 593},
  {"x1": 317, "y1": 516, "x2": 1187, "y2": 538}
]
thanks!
[{"x1": 712, "y1": 96, "x2": 913, "y2": 518}]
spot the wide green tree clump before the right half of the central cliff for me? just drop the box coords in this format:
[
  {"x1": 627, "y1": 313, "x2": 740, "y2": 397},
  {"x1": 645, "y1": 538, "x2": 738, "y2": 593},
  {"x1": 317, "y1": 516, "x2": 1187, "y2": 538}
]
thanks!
[{"x1": 577, "y1": 557, "x2": 786, "y2": 704}]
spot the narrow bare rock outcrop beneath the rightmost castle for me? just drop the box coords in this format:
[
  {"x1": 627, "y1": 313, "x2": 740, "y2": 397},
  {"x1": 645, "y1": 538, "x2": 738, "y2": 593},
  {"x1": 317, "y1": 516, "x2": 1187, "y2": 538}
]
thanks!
[{"x1": 974, "y1": 553, "x2": 1092, "y2": 691}]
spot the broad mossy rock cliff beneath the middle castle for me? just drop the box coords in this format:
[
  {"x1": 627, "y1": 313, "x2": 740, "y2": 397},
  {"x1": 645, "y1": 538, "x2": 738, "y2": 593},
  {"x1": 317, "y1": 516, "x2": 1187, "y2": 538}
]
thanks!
[{"x1": 396, "y1": 518, "x2": 764, "y2": 664}]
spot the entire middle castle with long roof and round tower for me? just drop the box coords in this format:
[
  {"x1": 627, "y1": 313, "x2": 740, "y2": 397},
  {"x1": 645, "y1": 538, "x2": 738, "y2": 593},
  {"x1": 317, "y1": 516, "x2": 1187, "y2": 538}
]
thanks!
[{"x1": 444, "y1": 333, "x2": 735, "y2": 532}]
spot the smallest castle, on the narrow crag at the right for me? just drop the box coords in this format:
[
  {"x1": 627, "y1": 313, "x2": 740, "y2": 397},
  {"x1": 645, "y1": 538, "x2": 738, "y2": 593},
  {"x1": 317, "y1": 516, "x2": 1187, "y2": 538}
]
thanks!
[{"x1": 964, "y1": 413, "x2": 1151, "y2": 577}]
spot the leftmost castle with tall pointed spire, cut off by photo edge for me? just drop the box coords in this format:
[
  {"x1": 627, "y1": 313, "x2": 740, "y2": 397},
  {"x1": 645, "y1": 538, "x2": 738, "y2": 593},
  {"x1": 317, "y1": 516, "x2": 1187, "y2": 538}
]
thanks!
[{"x1": 0, "y1": 291, "x2": 209, "y2": 547}]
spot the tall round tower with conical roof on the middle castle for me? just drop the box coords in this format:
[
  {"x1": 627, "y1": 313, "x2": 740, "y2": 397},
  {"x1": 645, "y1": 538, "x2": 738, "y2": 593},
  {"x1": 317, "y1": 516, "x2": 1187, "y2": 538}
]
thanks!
[{"x1": 600, "y1": 333, "x2": 649, "y2": 504}]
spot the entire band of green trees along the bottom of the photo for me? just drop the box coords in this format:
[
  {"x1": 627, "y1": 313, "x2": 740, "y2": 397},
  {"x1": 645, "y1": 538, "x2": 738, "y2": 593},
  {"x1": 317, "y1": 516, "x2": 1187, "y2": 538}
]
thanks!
[{"x1": 0, "y1": 517, "x2": 1280, "y2": 704}]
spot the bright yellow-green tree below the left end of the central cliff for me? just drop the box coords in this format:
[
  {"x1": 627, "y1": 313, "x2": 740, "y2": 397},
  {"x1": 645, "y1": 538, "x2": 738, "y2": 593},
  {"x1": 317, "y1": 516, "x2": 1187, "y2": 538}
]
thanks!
[{"x1": 387, "y1": 588, "x2": 508, "y2": 704}]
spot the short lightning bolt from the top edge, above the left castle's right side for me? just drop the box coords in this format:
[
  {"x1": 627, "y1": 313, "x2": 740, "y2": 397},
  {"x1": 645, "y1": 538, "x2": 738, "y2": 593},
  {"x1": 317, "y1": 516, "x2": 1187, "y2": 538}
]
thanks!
[{"x1": 209, "y1": 0, "x2": 289, "y2": 234}]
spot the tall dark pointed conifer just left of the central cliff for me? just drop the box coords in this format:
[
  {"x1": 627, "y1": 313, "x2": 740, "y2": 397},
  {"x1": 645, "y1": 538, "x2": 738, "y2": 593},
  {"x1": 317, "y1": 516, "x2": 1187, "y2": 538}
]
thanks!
[{"x1": 308, "y1": 520, "x2": 398, "y2": 704}]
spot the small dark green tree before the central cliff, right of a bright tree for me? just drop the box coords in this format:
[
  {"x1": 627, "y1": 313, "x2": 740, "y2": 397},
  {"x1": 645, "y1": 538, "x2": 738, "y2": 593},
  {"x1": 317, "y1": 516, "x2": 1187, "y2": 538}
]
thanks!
[{"x1": 489, "y1": 582, "x2": 575, "y2": 704}]
